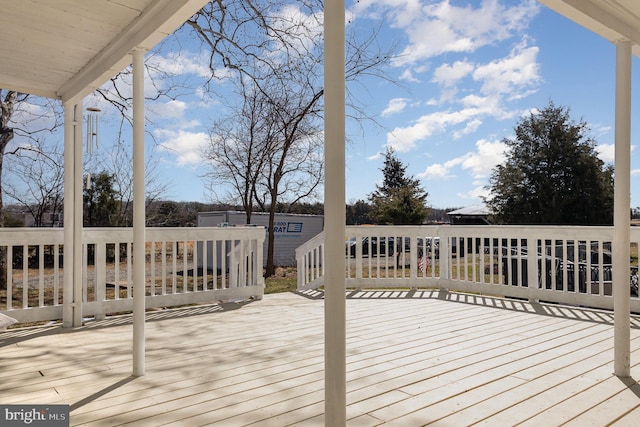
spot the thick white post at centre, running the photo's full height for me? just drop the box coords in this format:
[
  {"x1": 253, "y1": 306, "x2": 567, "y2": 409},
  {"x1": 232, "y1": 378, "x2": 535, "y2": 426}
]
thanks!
[{"x1": 324, "y1": 0, "x2": 347, "y2": 427}]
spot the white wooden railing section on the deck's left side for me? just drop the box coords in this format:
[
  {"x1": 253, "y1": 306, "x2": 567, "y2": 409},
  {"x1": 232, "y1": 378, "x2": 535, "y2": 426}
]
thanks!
[{"x1": 0, "y1": 227, "x2": 265, "y2": 322}]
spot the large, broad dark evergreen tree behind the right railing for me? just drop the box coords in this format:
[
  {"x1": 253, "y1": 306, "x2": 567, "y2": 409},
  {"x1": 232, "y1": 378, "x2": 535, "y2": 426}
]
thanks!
[{"x1": 485, "y1": 103, "x2": 613, "y2": 225}]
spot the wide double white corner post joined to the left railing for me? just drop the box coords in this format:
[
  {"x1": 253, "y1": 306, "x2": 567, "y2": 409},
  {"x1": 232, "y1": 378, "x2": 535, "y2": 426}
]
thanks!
[{"x1": 62, "y1": 101, "x2": 82, "y2": 328}]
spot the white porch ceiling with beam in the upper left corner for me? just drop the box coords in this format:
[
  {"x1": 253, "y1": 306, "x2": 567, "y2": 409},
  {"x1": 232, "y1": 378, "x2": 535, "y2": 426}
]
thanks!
[{"x1": 0, "y1": 0, "x2": 207, "y2": 101}]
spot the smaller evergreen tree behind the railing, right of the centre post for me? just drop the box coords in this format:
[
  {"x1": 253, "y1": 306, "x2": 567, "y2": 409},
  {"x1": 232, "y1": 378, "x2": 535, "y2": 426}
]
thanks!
[{"x1": 369, "y1": 148, "x2": 429, "y2": 225}]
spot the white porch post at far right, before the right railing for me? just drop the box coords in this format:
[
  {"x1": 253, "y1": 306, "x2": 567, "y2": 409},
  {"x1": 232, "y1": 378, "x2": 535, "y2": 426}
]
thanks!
[{"x1": 612, "y1": 40, "x2": 631, "y2": 377}]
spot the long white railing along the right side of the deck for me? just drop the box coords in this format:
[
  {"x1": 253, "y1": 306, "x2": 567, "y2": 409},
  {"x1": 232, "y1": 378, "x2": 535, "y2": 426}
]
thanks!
[{"x1": 297, "y1": 225, "x2": 640, "y2": 312}]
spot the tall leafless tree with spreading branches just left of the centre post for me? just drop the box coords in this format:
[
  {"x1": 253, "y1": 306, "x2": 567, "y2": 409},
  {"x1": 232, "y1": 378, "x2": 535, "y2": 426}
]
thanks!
[{"x1": 187, "y1": 0, "x2": 390, "y2": 276}]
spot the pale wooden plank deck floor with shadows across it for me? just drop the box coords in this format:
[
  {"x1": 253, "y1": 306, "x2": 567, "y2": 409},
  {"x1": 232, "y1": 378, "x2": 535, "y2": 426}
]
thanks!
[{"x1": 0, "y1": 291, "x2": 640, "y2": 427}]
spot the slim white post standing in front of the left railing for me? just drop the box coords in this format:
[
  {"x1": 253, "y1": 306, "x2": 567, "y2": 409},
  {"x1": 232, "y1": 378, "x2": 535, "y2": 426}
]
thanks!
[{"x1": 131, "y1": 49, "x2": 146, "y2": 376}]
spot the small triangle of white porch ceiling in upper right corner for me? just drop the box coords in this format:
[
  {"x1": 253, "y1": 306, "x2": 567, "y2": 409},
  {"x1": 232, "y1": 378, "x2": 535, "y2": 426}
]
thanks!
[{"x1": 538, "y1": 0, "x2": 640, "y2": 57}]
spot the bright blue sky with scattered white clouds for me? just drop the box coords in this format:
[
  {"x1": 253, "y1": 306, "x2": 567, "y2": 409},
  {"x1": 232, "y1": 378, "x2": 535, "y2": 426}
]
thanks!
[{"x1": 74, "y1": 0, "x2": 640, "y2": 208}]
